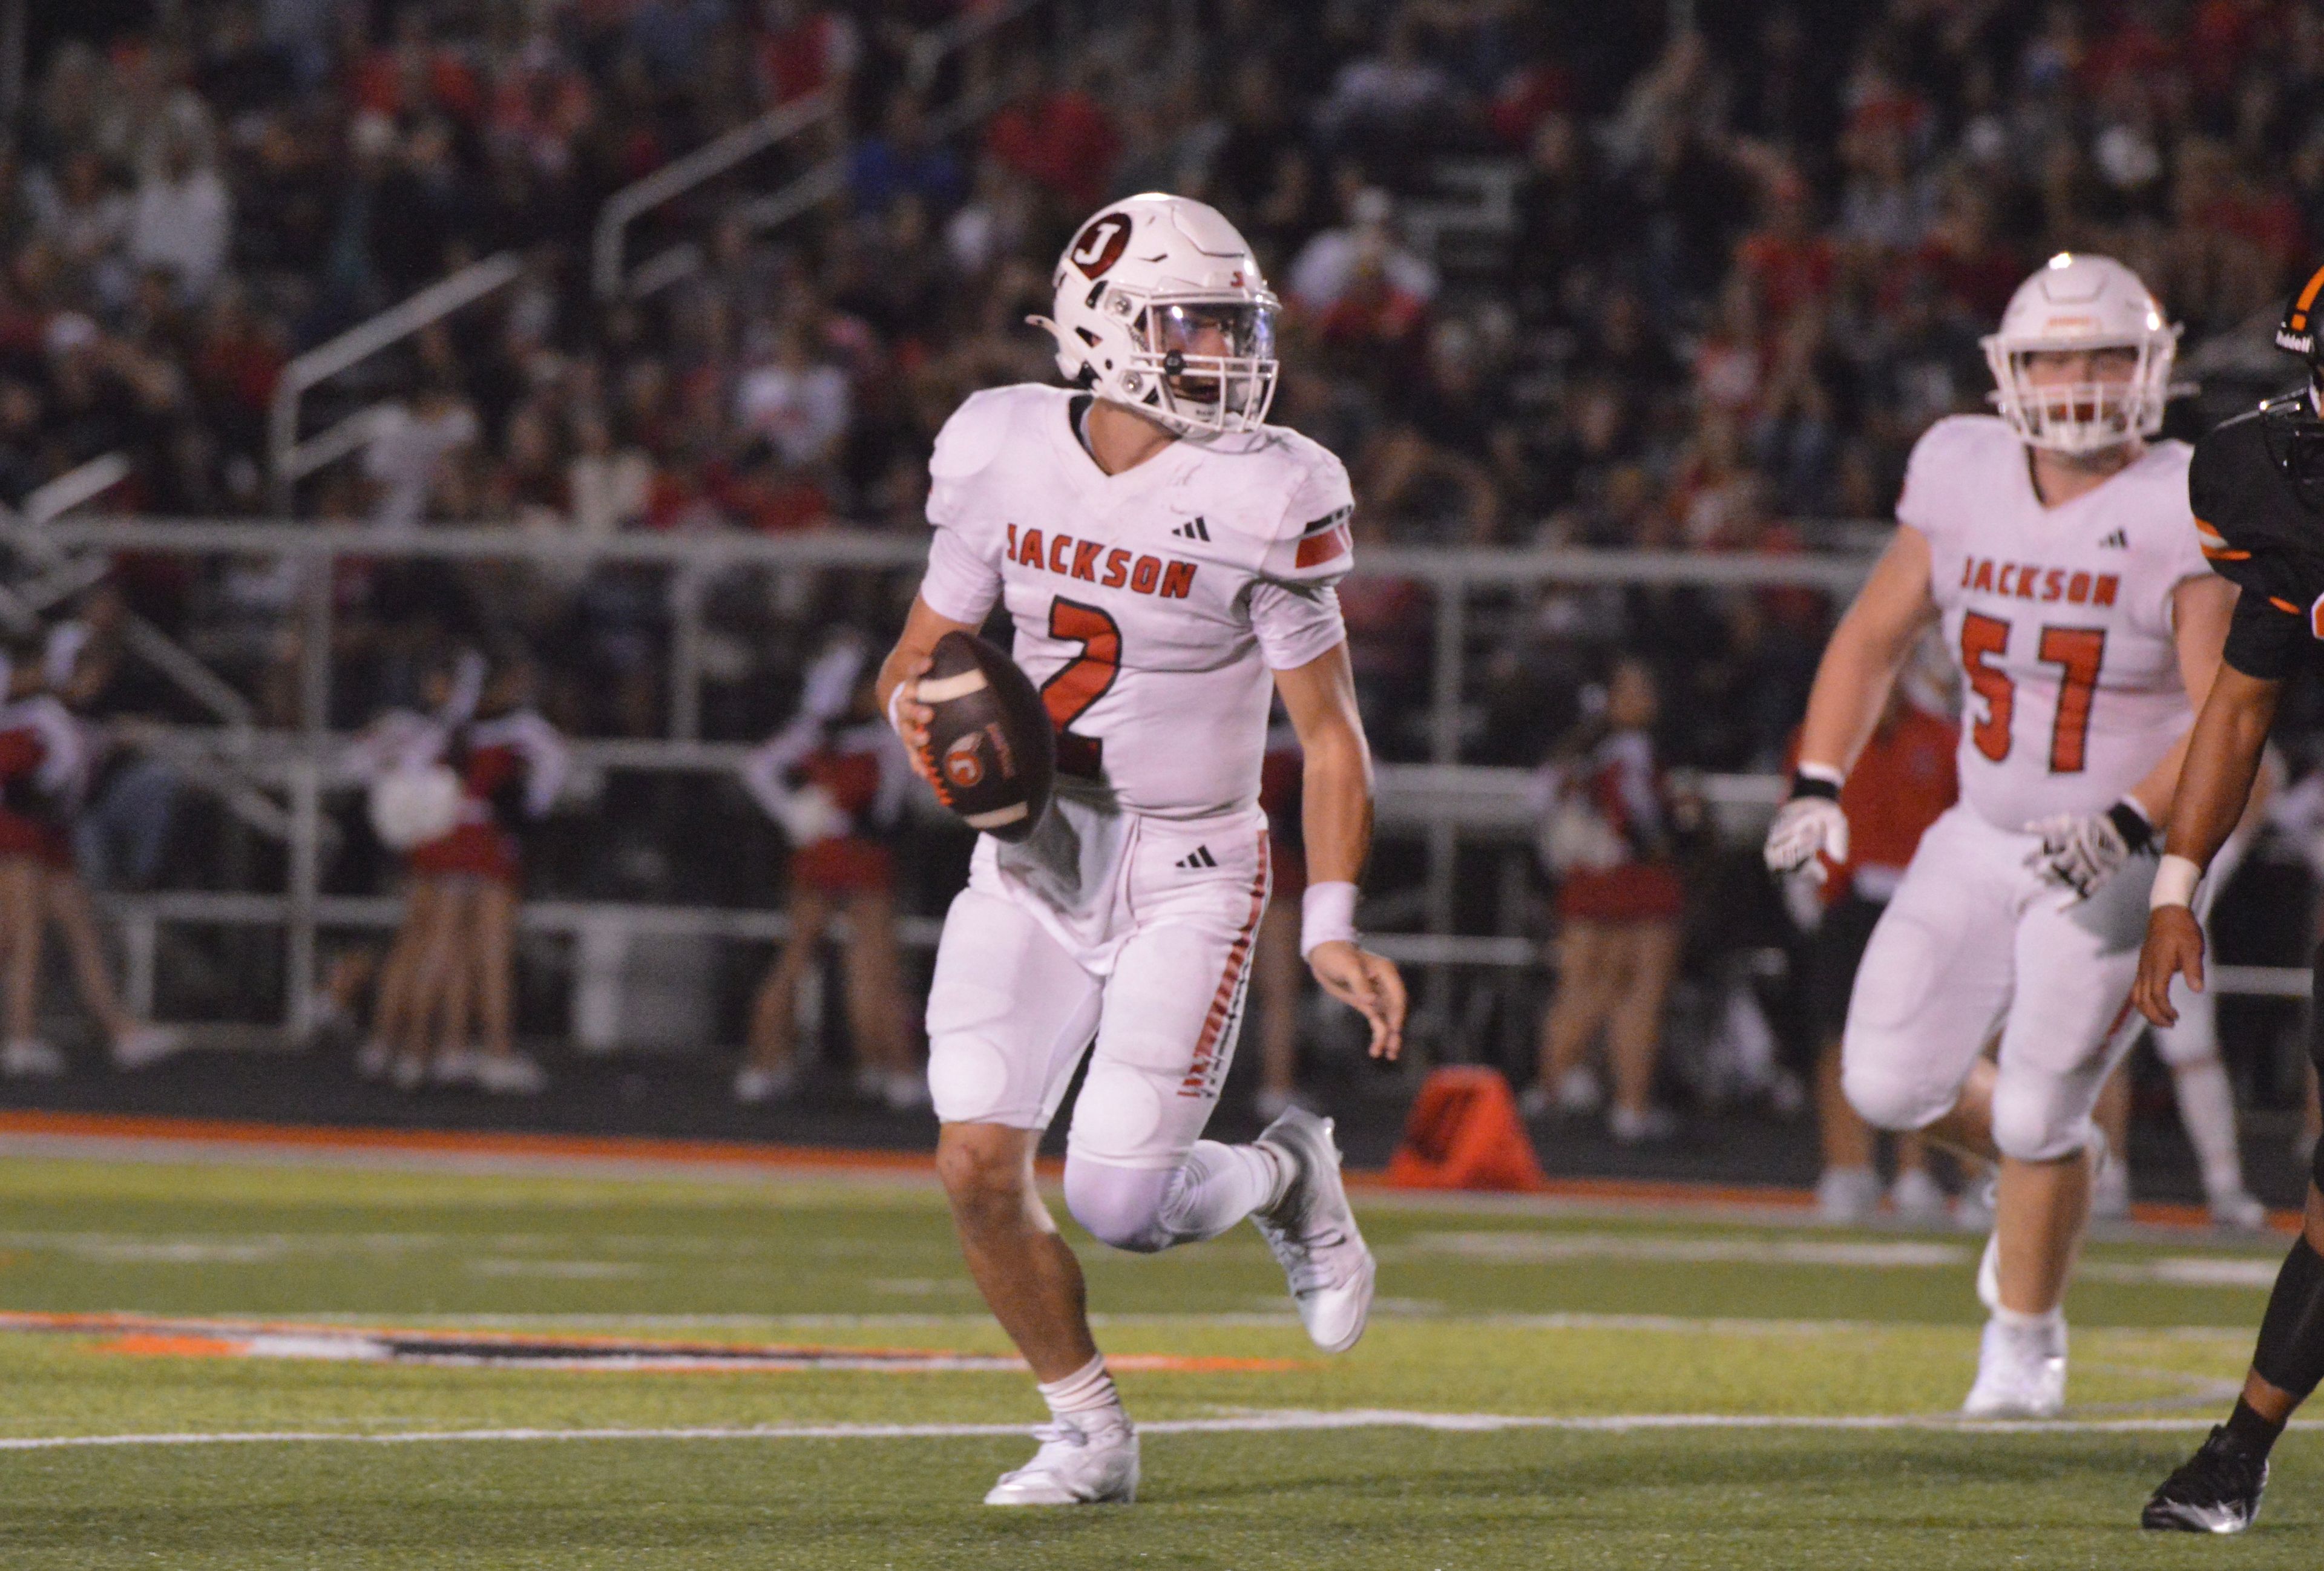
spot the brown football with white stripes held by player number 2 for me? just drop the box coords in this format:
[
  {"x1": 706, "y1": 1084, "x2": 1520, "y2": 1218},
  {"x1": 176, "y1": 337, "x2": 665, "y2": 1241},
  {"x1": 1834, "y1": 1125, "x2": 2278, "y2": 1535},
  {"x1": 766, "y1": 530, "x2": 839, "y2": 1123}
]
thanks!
[{"x1": 918, "y1": 632, "x2": 1057, "y2": 841}]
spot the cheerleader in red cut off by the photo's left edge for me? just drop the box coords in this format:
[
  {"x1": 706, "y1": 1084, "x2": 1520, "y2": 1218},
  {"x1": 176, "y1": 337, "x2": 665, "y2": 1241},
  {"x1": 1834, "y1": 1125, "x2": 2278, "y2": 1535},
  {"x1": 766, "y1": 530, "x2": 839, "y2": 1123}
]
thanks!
[{"x1": 0, "y1": 646, "x2": 88, "y2": 1076}]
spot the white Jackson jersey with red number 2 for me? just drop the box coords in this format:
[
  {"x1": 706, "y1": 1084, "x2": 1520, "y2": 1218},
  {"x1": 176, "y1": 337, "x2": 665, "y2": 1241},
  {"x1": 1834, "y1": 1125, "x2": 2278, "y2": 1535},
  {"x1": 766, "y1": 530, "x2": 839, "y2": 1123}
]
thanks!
[{"x1": 921, "y1": 384, "x2": 1353, "y2": 818}]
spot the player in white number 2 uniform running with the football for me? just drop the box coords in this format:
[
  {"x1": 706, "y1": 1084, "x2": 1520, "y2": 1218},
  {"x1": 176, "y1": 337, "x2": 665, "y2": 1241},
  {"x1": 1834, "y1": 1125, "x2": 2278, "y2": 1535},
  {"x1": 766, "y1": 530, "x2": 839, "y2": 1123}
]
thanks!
[{"x1": 881, "y1": 195, "x2": 1403, "y2": 1506}]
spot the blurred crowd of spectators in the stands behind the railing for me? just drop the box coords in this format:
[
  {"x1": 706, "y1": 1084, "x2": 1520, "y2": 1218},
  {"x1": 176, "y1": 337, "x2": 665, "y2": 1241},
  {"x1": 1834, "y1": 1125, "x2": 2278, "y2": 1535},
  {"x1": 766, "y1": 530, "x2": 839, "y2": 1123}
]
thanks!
[{"x1": 0, "y1": 0, "x2": 2324, "y2": 1129}]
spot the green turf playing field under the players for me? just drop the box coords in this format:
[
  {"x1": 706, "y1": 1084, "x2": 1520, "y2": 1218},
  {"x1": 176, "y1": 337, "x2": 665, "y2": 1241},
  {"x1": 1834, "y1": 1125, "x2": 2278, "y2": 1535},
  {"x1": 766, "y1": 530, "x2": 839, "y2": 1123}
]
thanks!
[{"x1": 0, "y1": 1157, "x2": 2324, "y2": 1571}]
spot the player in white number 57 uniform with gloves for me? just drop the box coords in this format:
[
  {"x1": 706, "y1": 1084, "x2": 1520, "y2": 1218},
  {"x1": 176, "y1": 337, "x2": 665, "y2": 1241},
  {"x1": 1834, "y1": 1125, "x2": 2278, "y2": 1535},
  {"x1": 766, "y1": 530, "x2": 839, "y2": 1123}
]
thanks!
[{"x1": 1766, "y1": 255, "x2": 2233, "y2": 1418}]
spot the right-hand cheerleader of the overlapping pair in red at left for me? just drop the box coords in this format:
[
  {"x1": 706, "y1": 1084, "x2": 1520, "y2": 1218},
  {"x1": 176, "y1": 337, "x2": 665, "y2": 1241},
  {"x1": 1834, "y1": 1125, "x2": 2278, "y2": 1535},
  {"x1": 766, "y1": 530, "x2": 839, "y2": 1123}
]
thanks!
[{"x1": 399, "y1": 660, "x2": 570, "y2": 1097}]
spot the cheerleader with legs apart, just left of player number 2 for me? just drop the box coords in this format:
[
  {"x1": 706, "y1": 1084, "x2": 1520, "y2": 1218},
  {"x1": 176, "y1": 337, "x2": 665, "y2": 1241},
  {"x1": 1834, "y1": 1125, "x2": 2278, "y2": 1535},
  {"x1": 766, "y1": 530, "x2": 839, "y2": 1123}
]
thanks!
[{"x1": 734, "y1": 634, "x2": 927, "y2": 1109}]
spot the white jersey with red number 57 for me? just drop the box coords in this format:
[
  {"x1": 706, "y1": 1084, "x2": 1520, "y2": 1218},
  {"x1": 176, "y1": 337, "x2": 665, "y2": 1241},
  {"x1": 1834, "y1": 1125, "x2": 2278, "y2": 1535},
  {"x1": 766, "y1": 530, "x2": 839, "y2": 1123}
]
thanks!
[{"x1": 1896, "y1": 416, "x2": 2210, "y2": 830}]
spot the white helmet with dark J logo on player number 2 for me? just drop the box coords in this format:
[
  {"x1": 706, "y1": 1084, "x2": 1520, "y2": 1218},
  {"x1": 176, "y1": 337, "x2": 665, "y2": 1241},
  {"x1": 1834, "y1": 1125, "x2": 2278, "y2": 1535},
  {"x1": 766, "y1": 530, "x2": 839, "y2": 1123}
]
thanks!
[{"x1": 1027, "y1": 193, "x2": 1281, "y2": 437}]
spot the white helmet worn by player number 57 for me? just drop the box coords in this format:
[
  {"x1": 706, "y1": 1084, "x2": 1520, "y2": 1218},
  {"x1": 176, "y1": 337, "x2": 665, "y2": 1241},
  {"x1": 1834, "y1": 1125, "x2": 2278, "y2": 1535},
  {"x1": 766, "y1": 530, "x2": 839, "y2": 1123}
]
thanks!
[{"x1": 1978, "y1": 251, "x2": 2180, "y2": 453}]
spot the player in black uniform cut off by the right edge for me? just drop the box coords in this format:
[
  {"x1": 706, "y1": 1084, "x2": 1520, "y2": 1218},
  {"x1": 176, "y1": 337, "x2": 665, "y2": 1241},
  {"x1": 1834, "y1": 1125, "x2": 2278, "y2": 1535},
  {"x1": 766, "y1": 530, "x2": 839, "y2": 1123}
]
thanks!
[{"x1": 2131, "y1": 269, "x2": 2324, "y2": 1534}]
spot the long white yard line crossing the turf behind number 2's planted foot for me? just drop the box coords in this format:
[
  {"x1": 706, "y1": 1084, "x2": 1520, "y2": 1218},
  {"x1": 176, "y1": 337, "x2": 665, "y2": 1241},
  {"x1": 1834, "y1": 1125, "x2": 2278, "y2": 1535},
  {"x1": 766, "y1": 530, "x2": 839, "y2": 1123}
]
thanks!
[{"x1": 0, "y1": 1408, "x2": 2286, "y2": 1450}]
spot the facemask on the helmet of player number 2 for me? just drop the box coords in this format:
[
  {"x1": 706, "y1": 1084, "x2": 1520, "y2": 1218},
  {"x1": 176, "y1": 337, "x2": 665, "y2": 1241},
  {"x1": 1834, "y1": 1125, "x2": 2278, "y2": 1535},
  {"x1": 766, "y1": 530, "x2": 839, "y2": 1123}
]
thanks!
[{"x1": 1106, "y1": 290, "x2": 1281, "y2": 435}]
